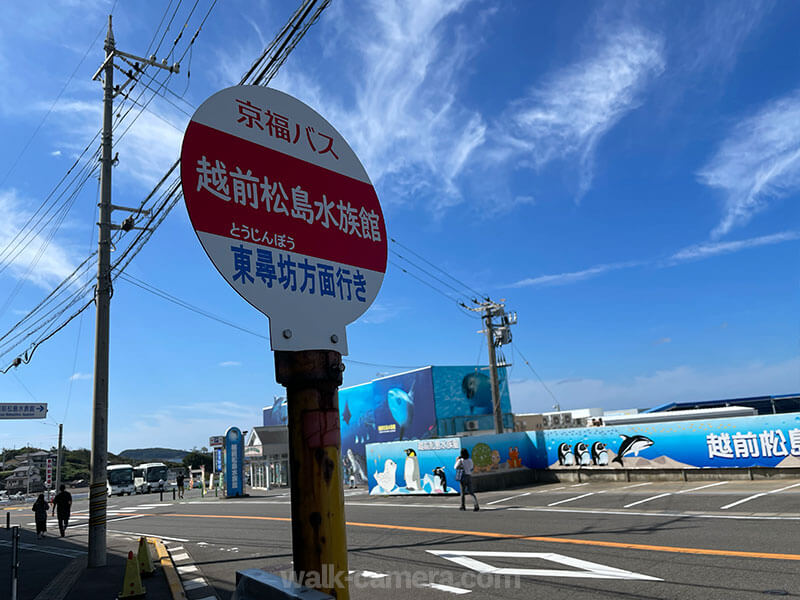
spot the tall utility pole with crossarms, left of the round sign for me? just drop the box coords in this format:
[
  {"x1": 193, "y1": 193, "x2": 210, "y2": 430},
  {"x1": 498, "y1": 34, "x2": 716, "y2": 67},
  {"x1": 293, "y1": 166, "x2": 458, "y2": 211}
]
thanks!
[{"x1": 87, "y1": 15, "x2": 178, "y2": 568}]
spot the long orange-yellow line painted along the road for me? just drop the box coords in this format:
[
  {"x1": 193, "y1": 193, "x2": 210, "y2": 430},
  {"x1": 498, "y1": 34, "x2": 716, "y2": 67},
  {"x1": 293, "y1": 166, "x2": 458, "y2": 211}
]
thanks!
[{"x1": 155, "y1": 513, "x2": 800, "y2": 561}]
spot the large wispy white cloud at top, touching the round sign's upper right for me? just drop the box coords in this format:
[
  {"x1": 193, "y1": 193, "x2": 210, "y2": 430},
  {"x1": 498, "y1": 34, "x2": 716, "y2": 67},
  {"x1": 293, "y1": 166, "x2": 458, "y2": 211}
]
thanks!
[{"x1": 275, "y1": 0, "x2": 486, "y2": 213}]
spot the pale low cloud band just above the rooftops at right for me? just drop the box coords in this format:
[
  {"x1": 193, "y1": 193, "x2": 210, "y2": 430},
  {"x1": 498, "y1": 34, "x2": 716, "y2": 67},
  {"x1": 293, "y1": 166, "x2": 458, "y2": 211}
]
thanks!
[{"x1": 510, "y1": 358, "x2": 800, "y2": 413}]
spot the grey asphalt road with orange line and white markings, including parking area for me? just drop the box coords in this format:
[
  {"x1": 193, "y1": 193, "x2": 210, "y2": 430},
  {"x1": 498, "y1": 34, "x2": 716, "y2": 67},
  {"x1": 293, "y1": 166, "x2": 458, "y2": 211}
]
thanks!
[{"x1": 6, "y1": 480, "x2": 800, "y2": 600}]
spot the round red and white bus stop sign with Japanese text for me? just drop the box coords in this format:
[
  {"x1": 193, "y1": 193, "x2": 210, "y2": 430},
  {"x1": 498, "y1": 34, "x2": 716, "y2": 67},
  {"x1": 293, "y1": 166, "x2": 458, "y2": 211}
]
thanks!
[{"x1": 181, "y1": 86, "x2": 387, "y2": 354}]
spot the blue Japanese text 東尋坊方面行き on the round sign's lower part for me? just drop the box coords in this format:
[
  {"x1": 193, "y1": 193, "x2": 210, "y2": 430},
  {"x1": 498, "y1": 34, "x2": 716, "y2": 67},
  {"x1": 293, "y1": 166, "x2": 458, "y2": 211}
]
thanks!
[{"x1": 231, "y1": 244, "x2": 367, "y2": 302}]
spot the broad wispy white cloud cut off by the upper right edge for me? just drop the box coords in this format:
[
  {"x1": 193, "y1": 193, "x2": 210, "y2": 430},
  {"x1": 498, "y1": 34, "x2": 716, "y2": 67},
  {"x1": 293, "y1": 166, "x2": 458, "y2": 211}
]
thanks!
[{"x1": 699, "y1": 90, "x2": 800, "y2": 238}]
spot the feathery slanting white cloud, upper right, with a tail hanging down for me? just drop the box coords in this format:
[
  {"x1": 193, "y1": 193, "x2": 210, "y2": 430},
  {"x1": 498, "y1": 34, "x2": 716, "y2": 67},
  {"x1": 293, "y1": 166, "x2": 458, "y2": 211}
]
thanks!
[{"x1": 494, "y1": 28, "x2": 664, "y2": 196}]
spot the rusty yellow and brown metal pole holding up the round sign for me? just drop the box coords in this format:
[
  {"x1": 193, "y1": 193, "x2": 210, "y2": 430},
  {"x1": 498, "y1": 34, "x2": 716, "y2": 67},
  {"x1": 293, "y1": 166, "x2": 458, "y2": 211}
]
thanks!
[{"x1": 275, "y1": 350, "x2": 350, "y2": 600}]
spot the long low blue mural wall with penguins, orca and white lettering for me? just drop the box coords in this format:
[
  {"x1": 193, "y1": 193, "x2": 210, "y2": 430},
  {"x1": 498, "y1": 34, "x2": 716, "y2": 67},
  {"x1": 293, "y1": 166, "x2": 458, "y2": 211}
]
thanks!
[{"x1": 367, "y1": 413, "x2": 800, "y2": 494}]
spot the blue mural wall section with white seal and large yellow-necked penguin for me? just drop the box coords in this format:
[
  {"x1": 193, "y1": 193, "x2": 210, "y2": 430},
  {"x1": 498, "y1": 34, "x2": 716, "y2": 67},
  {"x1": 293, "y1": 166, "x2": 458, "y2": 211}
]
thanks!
[{"x1": 366, "y1": 438, "x2": 461, "y2": 495}]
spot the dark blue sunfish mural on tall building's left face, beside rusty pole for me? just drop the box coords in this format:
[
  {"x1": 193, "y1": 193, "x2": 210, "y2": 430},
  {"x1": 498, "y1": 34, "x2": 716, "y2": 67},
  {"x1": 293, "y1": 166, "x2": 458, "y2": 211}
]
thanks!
[{"x1": 339, "y1": 367, "x2": 436, "y2": 484}]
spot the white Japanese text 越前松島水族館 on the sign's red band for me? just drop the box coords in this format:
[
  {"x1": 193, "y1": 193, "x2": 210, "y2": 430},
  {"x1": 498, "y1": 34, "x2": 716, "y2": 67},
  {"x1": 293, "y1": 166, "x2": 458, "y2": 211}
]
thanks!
[{"x1": 195, "y1": 155, "x2": 381, "y2": 242}]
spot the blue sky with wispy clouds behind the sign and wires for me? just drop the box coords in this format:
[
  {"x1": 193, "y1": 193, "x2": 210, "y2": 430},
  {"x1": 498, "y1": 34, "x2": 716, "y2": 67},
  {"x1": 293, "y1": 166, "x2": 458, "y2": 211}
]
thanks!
[{"x1": 0, "y1": 0, "x2": 800, "y2": 451}]
